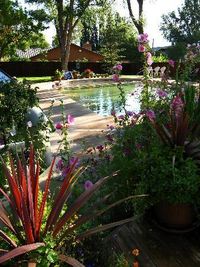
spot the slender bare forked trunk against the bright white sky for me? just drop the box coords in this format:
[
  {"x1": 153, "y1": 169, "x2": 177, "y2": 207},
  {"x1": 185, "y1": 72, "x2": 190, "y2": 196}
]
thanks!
[{"x1": 126, "y1": 0, "x2": 144, "y2": 34}]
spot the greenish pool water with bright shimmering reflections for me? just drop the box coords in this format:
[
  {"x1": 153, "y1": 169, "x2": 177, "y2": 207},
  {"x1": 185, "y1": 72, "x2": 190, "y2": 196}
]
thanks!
[{"x1": 65, "y1": 83, "x2": 141, "y2": 116}]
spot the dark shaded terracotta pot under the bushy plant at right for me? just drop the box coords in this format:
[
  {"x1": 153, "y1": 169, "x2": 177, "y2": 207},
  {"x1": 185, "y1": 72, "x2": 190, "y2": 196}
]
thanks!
[{"x1": 154, "y1": 201, "x2": 196, "y2": 230}]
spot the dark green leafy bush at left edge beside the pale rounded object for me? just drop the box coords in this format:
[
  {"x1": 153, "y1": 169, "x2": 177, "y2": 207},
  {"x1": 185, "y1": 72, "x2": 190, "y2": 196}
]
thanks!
[{"x1": 0, "y1": 81, "x2": 38, "y2": 147}]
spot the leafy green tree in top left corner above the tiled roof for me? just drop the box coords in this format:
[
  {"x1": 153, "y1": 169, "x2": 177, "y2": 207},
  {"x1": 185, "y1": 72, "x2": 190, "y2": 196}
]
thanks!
[{"x1": 0, "y1": 0, "x2": 47, "y2": 59}]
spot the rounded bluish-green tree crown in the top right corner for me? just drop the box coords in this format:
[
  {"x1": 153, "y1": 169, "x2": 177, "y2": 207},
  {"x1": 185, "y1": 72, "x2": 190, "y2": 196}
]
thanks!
[{"x1": 160, "y1": 0, "x2": 200, "y2": 44}]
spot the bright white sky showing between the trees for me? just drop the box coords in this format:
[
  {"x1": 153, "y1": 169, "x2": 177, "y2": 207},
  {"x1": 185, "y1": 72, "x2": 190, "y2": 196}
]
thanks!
[{"x1": 20, "y1": 0, "x2": 184, "y2": 47}]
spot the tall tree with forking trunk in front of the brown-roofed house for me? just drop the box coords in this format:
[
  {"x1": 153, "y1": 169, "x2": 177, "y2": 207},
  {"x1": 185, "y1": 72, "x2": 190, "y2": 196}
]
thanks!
[{"x1": 26, "y1": 0, "x2": 106, "y2": 71}]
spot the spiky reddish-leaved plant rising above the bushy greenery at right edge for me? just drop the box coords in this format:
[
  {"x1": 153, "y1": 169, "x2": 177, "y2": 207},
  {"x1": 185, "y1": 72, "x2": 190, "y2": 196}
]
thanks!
[{"x1": 150, "y1": 86, "x2": 200, "y2": 164}]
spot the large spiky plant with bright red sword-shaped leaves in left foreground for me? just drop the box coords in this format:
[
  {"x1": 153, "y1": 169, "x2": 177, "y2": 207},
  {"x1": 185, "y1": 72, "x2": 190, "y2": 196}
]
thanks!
[{"x1": 0, "y1": 146, "x2": 136, "y2": 266}]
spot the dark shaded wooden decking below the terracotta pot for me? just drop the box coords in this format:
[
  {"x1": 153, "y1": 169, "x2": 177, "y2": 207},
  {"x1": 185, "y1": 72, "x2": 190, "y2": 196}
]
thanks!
[{"x1": 109, "y1": 219, "x2": 200, "y2": 267}]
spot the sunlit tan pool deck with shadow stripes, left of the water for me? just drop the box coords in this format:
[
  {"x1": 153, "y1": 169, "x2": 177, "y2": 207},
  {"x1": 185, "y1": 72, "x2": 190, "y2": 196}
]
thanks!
[{"x1": 32, "y1": 79, "x2": 118, "y2": 161}]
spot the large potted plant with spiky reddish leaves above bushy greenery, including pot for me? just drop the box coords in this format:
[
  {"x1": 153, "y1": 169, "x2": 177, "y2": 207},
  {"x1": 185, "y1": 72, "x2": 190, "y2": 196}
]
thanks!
[{"x1": 136, "y1": 86, "x2": 200, "y2": 229}]
